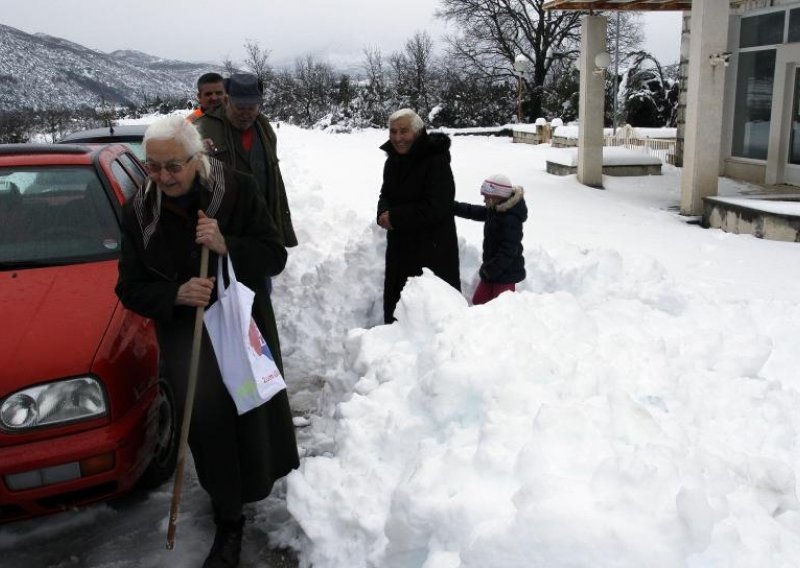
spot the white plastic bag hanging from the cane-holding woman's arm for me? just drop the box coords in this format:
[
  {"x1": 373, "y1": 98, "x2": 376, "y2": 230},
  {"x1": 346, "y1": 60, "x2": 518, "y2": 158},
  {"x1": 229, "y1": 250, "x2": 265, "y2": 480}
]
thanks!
[{"x1": 203, "y1": 255, "x2": 286, "y2": 415}]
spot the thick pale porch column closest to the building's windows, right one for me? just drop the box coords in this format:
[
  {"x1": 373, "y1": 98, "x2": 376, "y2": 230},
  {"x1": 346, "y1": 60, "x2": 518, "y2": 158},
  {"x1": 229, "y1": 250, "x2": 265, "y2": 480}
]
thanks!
[{"x1": 681, "y1": 0, "x2": 730, "y2": 215}]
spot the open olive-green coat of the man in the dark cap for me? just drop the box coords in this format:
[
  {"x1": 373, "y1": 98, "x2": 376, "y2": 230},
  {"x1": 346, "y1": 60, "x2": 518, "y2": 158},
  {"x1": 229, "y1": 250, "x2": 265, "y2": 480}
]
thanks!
[{"x1": 194, "y1": 106, "x2": 297, "y2": 247}]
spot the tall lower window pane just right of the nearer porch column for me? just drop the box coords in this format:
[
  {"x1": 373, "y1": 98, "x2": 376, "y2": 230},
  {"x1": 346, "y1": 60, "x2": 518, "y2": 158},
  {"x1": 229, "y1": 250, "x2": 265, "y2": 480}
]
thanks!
[{"x1": 731, "y1": 49, "x2": 776, "y2": 160}]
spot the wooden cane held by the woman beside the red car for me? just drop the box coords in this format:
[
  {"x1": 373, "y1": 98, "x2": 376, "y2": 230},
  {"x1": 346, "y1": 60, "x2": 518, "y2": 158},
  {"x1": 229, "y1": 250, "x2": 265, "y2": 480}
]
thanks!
[{"x1": 167, "y1": 247, "x2": 208, "y2": 550}]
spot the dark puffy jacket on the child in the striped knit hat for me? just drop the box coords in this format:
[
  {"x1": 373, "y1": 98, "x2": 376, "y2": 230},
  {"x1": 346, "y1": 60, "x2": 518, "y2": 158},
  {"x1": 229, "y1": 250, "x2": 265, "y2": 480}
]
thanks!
[{"x1": 455, "y1": 187, "x2": 528, "y2": 284}]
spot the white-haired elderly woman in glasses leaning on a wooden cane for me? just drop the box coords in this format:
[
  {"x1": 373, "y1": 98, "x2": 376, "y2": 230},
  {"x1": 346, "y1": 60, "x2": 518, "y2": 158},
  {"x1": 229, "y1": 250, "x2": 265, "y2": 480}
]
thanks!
[{"x1": 116, "y1": 116, "x2": 299, "y2": 568}]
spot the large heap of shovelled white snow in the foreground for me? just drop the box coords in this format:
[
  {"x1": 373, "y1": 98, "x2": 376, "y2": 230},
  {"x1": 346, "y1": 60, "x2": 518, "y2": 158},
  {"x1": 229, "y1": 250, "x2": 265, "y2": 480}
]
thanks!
[{"x1": 288, "y1": 253, "x2": 800, "y2": 567}]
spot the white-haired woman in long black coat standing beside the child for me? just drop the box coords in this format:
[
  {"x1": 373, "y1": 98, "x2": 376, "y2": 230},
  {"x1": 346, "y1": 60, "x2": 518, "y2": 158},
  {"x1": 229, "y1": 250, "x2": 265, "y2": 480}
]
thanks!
[{"x1": 378, "y1": 109, "x2": 461, "y2": 323}]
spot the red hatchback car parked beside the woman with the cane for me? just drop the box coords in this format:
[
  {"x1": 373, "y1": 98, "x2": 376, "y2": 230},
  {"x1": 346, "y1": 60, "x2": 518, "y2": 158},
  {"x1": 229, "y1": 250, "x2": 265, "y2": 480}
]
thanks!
[{"x1": 0, "y1": 144, "x2": 177, "y2": 522}]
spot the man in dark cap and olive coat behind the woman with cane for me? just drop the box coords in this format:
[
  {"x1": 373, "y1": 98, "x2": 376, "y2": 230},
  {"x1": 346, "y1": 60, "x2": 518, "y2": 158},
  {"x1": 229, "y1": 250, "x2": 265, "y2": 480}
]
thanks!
[{"x1": 194, "y1": 73, "x2": 297, "y2": 247}]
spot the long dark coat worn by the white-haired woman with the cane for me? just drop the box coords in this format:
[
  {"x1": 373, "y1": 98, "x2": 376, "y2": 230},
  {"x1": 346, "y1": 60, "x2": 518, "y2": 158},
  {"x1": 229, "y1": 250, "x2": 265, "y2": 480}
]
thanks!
[{"x1": 116, "y1": 159, "x2": 299, "y2": 514}]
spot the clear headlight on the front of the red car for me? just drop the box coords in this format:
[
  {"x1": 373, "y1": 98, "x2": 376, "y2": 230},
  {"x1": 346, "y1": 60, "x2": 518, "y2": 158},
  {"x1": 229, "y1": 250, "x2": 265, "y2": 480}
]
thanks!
[{"x1": 0, "y1": 377, "x2": 108, "y2": 432}]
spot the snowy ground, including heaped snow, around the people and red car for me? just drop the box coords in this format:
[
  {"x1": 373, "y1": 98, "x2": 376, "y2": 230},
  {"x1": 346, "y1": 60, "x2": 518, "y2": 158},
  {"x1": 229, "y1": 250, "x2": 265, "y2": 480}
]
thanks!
[{"x1": 0, "y1": 121, "x2": 800, "y2": 568}]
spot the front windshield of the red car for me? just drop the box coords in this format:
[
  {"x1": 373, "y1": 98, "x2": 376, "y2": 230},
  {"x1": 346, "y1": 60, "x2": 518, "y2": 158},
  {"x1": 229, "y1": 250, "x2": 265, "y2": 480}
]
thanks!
[{"x1": 0, "y1": 166, "x2": 120, "y2": 269}]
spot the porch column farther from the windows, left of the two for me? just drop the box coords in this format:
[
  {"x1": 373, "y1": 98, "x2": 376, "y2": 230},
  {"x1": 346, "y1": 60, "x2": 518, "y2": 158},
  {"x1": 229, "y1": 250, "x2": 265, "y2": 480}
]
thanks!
[{"x1": 577, "y1": 16, "x2": 606, "y2": 188}]
